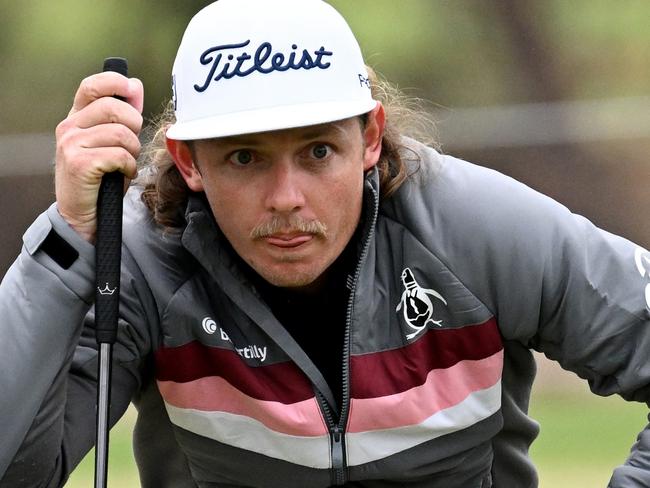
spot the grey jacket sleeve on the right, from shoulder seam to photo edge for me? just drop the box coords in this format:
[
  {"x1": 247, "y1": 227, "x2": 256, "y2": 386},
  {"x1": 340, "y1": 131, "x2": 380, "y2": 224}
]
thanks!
[{"x1": 422, "y1": 154, "x2": 650, "y2": 488}]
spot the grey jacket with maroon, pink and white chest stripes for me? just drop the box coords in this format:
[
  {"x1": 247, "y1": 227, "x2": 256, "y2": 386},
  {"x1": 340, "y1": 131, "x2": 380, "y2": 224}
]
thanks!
[{"x1": 0, "y1": 139, "x2": 650, "y2": 488}]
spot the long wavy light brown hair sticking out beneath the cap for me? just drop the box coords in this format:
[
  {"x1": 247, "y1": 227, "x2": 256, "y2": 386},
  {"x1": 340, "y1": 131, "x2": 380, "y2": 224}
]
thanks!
[{"x1": 135, "y1": 68, "x2": 438, "y2": 230}]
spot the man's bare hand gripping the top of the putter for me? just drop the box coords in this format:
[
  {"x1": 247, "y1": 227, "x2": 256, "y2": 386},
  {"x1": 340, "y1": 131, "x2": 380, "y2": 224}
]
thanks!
[{"x1": 55, "y1": 72, "x2": 144, "y2": 242}]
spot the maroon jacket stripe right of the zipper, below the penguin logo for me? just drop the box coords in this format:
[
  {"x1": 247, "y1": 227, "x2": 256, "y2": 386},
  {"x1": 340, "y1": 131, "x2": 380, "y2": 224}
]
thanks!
[{"x1": 350, "y1": 318, "x2": 503, "y2": 399}]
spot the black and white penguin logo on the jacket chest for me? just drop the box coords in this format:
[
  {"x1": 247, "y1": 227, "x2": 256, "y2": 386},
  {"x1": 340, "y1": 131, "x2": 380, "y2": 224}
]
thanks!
[{"x1": 395, "y1": 268, "x2": 447, "y2": 339}]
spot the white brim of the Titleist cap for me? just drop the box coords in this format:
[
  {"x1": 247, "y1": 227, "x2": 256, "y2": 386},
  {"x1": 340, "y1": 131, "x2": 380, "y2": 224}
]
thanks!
[{"x1": 166, "y1": 100, "x2": 377, "y2": 140}]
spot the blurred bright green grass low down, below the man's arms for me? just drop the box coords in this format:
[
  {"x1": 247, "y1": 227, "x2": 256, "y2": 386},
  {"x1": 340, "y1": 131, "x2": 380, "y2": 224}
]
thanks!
[{"x1": 66, "y1": 376, "x2": 648, "y2": 488}]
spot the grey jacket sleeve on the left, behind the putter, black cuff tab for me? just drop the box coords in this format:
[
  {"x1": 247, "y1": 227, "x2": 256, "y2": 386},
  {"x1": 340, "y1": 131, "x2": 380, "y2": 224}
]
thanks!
[{"x1": 0, "y1": 205, "x2": 150, "y2": 487}]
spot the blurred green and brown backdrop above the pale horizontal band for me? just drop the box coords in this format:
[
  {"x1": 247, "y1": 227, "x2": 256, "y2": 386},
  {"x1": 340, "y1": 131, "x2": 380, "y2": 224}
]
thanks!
[{"x1": 5, "y1": 0, "x2": 650, "y2": 134}]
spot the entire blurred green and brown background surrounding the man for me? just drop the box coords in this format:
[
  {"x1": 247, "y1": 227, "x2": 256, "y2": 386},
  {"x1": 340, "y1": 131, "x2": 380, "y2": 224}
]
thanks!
[{"x1": 0, "y1": 0, "x2": 650, "y2": 488}]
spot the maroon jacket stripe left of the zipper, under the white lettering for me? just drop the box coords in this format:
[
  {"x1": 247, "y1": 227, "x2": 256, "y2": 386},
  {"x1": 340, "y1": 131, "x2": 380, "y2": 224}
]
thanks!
[{"x1": 156, "y1": 341, "x2": 314, "y2": 404}]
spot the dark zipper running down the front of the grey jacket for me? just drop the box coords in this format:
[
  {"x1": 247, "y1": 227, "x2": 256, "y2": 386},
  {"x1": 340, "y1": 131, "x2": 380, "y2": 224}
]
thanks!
[{"x1": 317, "y1": 181, "x2": 379, "y2": 486}]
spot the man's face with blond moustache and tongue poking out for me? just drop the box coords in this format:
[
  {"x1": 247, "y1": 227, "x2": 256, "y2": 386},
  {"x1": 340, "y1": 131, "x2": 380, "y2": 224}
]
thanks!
[{"x1": 175, "y1": 110, "x2": 383, "y2": 288}]
